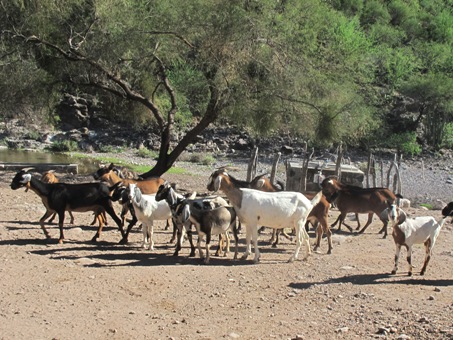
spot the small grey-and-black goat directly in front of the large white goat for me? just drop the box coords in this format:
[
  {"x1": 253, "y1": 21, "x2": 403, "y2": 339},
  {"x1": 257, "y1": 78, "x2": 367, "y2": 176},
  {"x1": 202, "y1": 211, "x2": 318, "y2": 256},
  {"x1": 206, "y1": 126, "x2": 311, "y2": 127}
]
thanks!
[{"x1": 179, "y1": 200, "x2": 238, "y2": 264}]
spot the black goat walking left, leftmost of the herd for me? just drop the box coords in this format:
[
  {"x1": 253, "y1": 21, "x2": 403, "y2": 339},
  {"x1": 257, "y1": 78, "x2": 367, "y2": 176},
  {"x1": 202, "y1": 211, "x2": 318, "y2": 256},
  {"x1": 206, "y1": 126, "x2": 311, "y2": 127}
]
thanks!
[{"x1": 11, "y1": 170, "x2": 124, "y2": 243}]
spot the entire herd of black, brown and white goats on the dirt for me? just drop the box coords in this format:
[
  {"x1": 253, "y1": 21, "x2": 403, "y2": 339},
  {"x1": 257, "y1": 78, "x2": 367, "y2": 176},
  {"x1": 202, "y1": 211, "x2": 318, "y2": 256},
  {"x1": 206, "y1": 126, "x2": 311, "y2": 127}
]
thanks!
[{"x1": 11, "y1": 164, "x2": 453, "y2": 275}]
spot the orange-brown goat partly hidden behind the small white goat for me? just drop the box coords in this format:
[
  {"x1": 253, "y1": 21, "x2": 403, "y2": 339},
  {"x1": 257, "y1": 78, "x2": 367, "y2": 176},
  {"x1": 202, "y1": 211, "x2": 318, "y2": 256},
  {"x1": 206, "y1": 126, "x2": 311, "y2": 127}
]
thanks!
[{"x1": 93, "y1": 163, "x2": 167, "y2": 243}]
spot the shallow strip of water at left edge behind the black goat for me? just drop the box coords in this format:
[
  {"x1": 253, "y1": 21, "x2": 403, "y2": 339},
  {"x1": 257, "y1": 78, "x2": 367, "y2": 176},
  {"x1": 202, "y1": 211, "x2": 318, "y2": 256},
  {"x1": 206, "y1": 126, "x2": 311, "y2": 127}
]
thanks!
[{"x1": 0, "y1": 149, "x2": 99, "y2": 175}]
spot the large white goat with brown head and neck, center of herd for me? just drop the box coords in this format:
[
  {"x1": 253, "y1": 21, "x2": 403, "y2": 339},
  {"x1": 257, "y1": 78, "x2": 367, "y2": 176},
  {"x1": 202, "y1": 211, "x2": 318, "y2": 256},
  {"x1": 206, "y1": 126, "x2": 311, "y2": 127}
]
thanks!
[{"x1": 207, "y1": 169, "x2": 322, "y2": 263}]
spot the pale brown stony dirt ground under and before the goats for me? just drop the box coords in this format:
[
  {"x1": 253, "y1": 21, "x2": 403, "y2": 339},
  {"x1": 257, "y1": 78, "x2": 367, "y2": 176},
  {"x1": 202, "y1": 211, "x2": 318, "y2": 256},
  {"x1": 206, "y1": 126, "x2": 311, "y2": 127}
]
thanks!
[{"x1": 0, "y1": 173, "x2": 453, "y2": 339}]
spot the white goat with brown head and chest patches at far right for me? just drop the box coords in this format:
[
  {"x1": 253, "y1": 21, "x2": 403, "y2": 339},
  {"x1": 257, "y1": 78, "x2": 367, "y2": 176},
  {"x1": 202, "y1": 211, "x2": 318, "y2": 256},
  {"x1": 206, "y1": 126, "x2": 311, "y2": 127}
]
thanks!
[{"x1": 381, "y1": 202, "x2": 453, "y2": 276}]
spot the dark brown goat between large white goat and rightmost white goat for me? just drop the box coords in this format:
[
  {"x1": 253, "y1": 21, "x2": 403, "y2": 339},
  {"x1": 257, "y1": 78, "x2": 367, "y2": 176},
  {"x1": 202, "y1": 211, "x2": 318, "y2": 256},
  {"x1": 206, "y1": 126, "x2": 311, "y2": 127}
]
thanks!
[{"x1": 321, "y1": 177, "x2": 396, "y2": 238}]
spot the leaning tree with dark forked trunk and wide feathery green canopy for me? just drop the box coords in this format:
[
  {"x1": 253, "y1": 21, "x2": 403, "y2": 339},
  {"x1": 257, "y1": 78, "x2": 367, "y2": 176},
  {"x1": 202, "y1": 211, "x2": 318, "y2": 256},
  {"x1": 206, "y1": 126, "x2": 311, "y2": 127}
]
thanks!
[{"x1": 0, "y1": 0, "x2": 378, "y2": 177}]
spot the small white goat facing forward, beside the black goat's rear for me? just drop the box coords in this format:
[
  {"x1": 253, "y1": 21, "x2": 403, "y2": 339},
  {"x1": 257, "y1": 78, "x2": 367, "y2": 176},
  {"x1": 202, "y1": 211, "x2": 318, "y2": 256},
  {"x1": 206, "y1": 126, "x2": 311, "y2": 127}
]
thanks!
[{"x1": 129, "y1": 184, "x2": 171, "y2": 250}]
